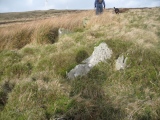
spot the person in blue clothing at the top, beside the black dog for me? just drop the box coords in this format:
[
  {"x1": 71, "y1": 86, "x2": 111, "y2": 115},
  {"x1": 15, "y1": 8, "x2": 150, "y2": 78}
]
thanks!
[{"x1": 94, "y1": 0, "x2": 105, "y2": 15}]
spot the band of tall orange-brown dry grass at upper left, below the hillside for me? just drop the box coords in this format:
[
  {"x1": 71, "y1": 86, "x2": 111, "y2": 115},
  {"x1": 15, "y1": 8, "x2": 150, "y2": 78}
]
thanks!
[{"x1": 0, "y1": 11, "x2": 110, "y2": 50}]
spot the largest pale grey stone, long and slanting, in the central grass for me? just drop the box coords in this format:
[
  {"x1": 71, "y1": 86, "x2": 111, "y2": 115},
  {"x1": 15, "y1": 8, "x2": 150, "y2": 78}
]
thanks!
[{"x1": 67, "y1": 43, "x2": 112, "y2": 79}]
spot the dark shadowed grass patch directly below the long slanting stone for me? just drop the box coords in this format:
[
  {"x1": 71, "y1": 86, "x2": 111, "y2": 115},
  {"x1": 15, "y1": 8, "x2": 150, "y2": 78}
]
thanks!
[{"x1": 67, "y1": 67, "x2": 125, "y2": 120}]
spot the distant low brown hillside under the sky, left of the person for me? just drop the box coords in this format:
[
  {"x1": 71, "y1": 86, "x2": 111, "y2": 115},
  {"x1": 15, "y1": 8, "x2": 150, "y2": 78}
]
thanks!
[{"x1": 0, "y1": 9, "x2": 84, "y2": 24}]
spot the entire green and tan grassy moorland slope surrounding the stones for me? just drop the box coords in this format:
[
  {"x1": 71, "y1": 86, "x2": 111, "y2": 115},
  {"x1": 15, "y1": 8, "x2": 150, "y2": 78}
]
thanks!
[{"x1": 0, "y1": 8, "x2": 160, "y2": 120}]
